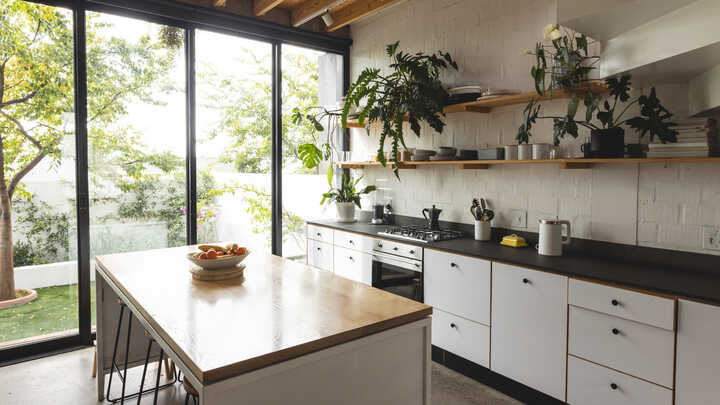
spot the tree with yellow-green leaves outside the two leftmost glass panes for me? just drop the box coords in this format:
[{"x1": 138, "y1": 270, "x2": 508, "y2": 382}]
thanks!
[{"x1": 0, "y1": 0, "x2": 177, "y2": 300}]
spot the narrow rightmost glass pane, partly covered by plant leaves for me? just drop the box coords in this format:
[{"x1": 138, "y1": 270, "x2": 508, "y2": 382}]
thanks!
[{"x1": 282, "y1": 45, "x2": 343, "y2": 262}]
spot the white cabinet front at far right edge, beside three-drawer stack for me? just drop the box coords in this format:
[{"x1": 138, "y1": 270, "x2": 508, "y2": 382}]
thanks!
[{"x1": 675, "y1": 300, "x2": 720, "y2": 405}]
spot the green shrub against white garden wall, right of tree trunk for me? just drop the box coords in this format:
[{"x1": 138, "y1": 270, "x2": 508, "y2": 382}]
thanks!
[{"x1": 13, "y1": 198, "x2": 74, "y2": 267}]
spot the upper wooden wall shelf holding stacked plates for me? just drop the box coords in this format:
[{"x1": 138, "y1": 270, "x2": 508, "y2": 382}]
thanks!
[{"x1": 347, "y1": 82, "x2": 608, "y2": 128}]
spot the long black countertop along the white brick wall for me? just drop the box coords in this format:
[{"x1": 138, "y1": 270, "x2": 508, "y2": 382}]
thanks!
[{"x1": 308, "y1": 219, "x2": 720, "y2": 304}]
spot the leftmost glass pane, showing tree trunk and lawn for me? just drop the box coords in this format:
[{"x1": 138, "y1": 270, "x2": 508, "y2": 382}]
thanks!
[{"x1": 0, "y1": 0, "x2": 78, "y2": 349}]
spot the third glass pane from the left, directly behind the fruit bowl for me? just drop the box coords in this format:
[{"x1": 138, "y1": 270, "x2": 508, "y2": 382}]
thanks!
[{"x1": 195, "y1": 30, "x2": 272, "y2": 252}]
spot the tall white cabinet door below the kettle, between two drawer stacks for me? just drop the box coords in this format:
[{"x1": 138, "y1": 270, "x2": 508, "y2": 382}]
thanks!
[{"x1": 490, "y1": 263, "x2": 568, "y2": 401}]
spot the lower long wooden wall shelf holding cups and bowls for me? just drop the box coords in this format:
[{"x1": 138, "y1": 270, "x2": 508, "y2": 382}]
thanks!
[{"x1": 340, "y1": 157, "x2": 720, "y2": 170}]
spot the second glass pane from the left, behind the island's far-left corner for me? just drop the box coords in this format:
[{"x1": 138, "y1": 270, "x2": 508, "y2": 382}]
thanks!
[{"x1": 86, "y1": 12, "x2": 186, "y2": 322}]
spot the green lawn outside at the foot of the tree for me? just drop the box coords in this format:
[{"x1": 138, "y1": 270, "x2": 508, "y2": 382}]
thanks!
[{"x1": 0, "y1": 283, "x2": 95, "y2": 342}]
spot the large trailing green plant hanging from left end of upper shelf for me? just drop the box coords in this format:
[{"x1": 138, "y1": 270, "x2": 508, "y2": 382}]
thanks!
[{"x1": 293, "y1": 42, "x2": 458, "y2": 176}]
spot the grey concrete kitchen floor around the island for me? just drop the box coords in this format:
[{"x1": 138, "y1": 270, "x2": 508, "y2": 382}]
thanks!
[{"x1": 0, "y1": 348, "x2": 520, "y2": 405}]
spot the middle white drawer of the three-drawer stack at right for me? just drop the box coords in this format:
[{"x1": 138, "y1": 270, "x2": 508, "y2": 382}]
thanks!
[{"x1": 568, "y1": 305, "x2": 675, "y2": 388}]
